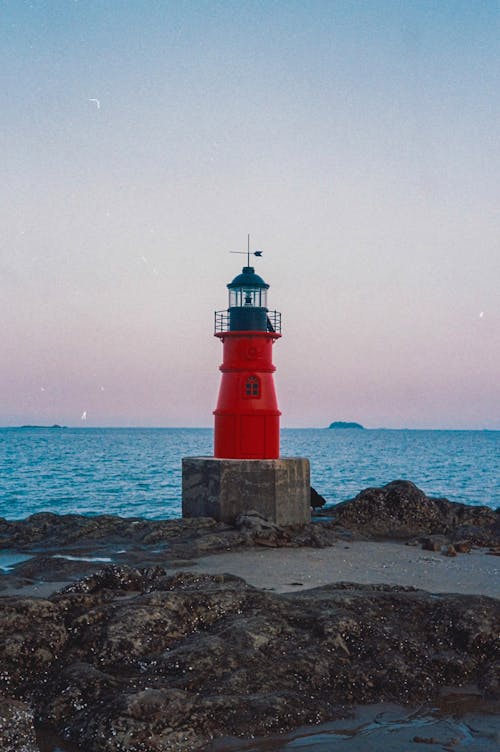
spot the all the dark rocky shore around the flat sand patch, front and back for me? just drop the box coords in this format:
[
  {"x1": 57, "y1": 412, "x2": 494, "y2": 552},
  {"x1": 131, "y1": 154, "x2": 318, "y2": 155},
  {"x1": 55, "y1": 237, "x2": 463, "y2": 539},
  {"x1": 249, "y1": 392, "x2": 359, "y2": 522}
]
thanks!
[{"x1": 0, "y1": 481, "x2": 500, "y2": 752}]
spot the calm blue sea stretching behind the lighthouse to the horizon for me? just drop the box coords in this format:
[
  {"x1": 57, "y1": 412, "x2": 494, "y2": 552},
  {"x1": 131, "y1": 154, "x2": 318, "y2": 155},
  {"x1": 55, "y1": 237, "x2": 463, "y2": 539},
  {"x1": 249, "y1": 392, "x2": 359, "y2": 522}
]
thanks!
[{"x1": 0, "y1": 428, "x2": 500, "y2": 519}]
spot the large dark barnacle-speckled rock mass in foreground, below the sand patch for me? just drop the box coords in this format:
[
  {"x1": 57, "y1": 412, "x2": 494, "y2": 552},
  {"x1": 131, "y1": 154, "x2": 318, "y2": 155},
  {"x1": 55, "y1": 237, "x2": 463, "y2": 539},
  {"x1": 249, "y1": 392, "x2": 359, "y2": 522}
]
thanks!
[{"x1": 0, "y1": 566, "x2": 500, "y2": 752}]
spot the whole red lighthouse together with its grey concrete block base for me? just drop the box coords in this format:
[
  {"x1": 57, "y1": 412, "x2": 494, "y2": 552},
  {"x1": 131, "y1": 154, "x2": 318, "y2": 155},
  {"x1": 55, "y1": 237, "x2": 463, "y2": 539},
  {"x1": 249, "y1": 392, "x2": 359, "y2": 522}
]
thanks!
[{"x1": 182, "y1": 247, "x2": 311, "y2": 526}]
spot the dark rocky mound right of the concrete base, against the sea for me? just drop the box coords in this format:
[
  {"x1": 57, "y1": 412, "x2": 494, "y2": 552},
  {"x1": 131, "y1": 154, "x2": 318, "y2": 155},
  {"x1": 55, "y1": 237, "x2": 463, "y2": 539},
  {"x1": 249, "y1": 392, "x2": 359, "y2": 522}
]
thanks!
[{"x1": 325, "y1": 480, "x2": 500, "y2": 546}]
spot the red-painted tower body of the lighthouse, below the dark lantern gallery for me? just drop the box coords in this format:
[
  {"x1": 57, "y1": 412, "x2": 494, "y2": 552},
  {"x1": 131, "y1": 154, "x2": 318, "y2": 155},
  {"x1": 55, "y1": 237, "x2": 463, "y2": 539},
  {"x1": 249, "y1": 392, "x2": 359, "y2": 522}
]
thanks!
[{"x1": 214, "y1": 331, "x2": 281, "y2": 459}]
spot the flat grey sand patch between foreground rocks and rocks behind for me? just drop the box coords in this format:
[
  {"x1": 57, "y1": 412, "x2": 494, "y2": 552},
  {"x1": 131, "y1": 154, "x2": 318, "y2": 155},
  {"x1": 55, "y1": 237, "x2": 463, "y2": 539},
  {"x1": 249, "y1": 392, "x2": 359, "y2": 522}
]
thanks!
[{"x1": 179, "y1": 541, "x2": 500, "y2": 598}]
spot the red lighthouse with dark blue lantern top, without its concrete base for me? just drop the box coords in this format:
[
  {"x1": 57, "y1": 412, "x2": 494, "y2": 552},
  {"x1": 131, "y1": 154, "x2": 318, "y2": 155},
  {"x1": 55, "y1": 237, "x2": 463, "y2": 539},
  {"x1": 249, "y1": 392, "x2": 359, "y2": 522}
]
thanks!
[{"x1": 214, "y1": 252, "x2": 281, "y2": 460}]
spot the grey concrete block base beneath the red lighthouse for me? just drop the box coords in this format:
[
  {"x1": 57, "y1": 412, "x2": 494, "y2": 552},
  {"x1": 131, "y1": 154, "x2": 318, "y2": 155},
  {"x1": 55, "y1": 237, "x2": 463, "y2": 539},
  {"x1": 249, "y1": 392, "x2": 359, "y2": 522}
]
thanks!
[{"x1": 182, "y1": 457, "x2": 311, "y2": 525}]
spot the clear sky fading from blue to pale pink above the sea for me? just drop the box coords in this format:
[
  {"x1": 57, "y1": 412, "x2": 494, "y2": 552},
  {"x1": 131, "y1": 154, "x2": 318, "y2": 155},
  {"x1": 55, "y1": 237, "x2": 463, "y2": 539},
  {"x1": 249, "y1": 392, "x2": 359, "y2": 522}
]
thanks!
[{"x1": 0, "y1": 0, "x2": 500, "y2": 429}]
